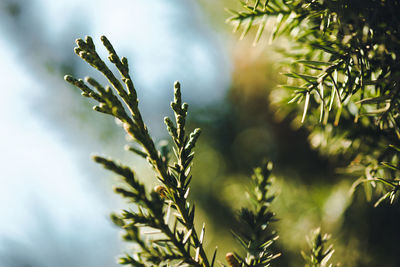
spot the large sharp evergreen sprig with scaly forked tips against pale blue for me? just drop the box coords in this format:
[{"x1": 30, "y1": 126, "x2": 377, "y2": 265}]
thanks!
[{"x1": 65, "y1": 36, "x2": 215, "y2": 267}]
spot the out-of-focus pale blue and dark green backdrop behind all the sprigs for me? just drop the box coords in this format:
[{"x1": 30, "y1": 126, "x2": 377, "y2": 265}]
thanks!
[{"x1": 0, "y1": 0, "x2": 400, "y2": 267}]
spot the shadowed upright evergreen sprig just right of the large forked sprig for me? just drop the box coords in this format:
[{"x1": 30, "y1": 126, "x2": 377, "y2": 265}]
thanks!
[{"x1": 226, "y1": 163, "x2": 280, "y2": 267}]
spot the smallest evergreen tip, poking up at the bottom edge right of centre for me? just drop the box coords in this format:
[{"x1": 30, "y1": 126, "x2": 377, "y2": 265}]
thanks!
[{"x1": 302, "y1": 228, "x2": 335, "y2": 267}]
